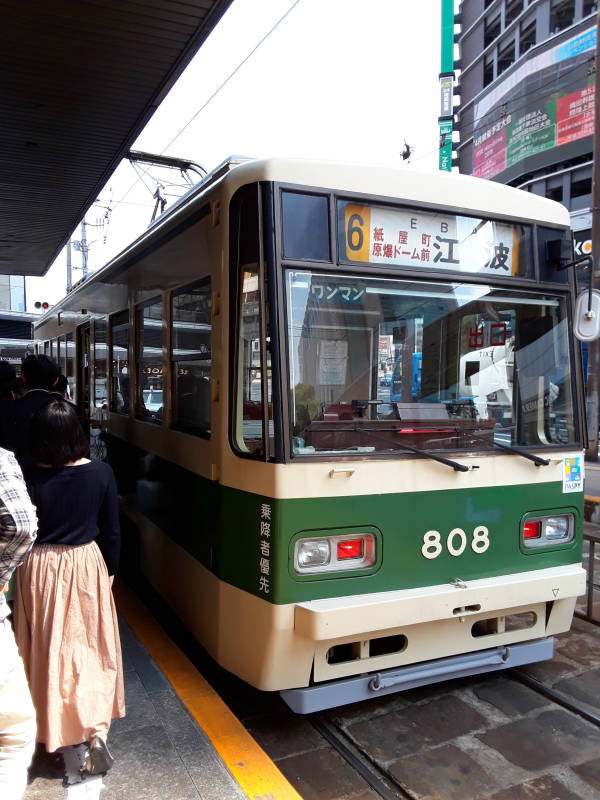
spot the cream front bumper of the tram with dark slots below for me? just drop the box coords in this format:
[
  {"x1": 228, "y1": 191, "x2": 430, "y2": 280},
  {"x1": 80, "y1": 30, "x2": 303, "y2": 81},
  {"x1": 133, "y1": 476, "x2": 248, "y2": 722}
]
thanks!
[{"x1": 294, "y1": 564, "x2": 586, "y2": 702}]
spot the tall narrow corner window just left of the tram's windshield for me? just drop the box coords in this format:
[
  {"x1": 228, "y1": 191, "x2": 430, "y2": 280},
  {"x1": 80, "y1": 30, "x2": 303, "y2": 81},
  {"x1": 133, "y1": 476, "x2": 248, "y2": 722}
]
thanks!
[{"x1": 231, "y1": 186, "x2": 273, "y2": 458}]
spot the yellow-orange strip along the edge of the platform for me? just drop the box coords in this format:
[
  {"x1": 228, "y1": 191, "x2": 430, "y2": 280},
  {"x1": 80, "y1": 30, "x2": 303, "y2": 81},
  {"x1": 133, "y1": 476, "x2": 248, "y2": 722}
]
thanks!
[{"x1": 115, "y1": 581, "x2": 302, "y2": 800}]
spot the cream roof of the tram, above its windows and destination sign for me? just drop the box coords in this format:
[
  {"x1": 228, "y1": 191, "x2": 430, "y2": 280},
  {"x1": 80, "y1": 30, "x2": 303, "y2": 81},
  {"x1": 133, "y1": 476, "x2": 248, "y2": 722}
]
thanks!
[{"x1": 36, "y1": 156, "x2": 570, "y2": 327}]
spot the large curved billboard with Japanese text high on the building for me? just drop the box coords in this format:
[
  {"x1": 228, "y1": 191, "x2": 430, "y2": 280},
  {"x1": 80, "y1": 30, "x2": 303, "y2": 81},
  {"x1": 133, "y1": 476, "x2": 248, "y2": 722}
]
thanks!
[{"x1": 471, "y1": 28, "x2": 596, "y2": 179}]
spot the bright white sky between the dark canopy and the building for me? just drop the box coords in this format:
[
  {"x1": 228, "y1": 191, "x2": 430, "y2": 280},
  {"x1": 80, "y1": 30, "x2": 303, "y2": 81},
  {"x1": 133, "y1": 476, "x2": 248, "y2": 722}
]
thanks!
[{"x1": 27, "y1": 0, "x2": 441, "y2": 311}]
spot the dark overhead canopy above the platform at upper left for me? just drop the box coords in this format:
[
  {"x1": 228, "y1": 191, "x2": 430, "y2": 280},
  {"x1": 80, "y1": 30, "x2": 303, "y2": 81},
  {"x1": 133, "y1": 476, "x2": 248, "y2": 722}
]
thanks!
[{"x1": 0, "y1": 0, "x2": 231, "y2": 275}]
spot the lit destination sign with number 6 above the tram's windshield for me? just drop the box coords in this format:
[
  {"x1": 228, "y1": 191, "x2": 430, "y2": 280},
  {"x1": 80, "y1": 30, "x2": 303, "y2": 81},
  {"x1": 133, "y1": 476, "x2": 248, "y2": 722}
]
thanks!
[{"x1": 340, "y1": 203, "x2": 530, "y2": 276}]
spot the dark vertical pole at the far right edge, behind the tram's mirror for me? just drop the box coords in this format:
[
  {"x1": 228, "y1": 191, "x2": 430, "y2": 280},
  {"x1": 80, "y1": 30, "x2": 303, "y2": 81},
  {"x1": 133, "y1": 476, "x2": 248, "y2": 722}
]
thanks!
[{"x1": 585, "y1": 11, "x2": 600, "y2": 461}]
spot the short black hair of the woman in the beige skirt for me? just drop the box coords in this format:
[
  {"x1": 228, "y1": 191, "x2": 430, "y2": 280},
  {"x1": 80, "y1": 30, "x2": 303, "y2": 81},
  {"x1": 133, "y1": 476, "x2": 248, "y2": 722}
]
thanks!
[{"x1": 29, "y1": 399, "x2": 90, "y2": 467}]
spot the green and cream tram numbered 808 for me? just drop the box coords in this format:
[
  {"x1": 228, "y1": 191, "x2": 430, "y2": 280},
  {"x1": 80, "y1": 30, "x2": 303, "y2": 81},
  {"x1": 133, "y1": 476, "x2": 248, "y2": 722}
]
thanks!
[{"x1": 36, "y1": 160, "x2": 585, "y2": 712}]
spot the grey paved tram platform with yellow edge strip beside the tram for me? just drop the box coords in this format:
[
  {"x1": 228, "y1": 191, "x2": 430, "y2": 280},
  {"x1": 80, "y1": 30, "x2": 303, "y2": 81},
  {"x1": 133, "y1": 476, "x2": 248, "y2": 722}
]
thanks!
[{"x1": 25, "y1": 582, "x2": 300, "y2": 800}]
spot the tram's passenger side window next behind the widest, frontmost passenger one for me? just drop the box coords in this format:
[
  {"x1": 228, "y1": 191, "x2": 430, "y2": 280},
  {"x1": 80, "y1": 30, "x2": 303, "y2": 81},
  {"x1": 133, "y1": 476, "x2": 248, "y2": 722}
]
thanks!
[{"x1": 135, "y1": 297, "x2": 164, "y2": 425}]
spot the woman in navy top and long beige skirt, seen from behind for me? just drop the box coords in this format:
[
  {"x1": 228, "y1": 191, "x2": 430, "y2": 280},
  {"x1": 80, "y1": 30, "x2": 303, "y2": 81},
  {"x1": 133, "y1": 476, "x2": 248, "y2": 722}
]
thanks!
[{"x1": 14, "y1": 399, "x2": 125, "y2": 783}]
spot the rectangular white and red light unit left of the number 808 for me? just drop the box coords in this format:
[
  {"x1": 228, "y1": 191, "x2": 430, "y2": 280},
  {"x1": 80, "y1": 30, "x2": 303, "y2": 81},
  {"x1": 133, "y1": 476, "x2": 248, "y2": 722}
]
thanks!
[{"x1": 294, "y1": 533, "x2": 375, "y2": 574}]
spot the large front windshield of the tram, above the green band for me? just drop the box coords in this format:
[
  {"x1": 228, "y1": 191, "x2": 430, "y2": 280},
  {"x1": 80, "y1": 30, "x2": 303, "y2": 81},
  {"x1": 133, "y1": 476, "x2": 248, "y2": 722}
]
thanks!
[{"x1": 286, "y1": 270, "x2": 577, "y2": 456}]
